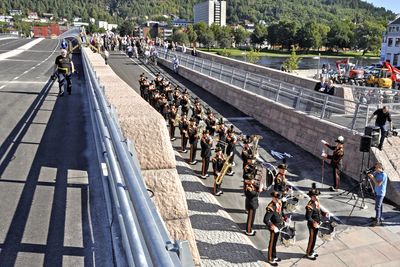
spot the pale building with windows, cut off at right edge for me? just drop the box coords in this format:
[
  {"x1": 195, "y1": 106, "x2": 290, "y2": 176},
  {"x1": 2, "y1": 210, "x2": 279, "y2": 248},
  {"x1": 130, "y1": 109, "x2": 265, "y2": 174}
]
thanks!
[{"x1": 380, "y1": 16, "x2": 400, "y2": 66}]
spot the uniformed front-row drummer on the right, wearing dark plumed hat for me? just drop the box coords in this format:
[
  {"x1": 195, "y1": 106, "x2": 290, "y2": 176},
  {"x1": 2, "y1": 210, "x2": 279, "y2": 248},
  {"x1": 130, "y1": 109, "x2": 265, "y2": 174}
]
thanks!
[{"x1": 306, "y1": 185, "x2": 329, "y2": 260}]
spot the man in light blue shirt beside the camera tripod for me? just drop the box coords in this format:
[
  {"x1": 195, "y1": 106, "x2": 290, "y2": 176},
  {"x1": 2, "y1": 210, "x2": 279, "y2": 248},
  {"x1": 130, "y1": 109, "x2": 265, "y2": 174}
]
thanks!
[{"x1": 366, "y1": 162, "x2": 387, "y2": 226}]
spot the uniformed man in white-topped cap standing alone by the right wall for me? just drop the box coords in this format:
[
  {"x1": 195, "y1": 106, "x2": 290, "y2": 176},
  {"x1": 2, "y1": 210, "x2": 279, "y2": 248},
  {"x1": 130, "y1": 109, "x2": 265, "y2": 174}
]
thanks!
[{"x1": 324, "y1": 136, "x2": 344, "y2": 192}]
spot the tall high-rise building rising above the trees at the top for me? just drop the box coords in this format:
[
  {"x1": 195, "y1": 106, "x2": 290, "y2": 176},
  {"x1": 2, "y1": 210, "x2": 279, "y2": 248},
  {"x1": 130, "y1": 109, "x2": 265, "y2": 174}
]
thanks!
[{"x1": 193, "y1": 0, "x2": 226, "y2": 26}]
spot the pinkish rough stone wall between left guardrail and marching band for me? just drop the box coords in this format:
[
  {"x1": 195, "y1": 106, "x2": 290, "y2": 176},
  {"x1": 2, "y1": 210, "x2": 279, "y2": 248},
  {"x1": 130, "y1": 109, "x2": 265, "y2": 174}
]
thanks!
[{"x1": 83, "y1": 48, "x2": 201, "y2": 266}]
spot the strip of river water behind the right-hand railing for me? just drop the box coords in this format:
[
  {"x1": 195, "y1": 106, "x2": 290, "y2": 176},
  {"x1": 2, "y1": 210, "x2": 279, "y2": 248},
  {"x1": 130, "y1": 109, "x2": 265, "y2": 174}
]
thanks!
[{"x1": 232, "y1": 56, "x2": 379, "y2": 70}]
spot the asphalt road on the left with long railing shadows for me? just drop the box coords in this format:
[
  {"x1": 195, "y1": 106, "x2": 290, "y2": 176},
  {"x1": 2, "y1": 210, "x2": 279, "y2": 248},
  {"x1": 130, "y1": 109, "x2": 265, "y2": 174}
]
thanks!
[{"x1": 0, "y1": 39, "x2": 113, "y2": 266}]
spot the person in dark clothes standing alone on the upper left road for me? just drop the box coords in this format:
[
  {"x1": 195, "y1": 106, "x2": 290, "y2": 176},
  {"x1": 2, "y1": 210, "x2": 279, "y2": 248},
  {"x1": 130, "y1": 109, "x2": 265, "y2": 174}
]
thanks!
[{"x1": 54, "y1": 49, "x2": 75, "y2": 97}]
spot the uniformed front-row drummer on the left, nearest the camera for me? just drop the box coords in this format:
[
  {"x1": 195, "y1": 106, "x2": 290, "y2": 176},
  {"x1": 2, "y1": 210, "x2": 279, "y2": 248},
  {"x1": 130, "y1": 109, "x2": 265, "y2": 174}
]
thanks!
[{"x1": 264, "y1": 191, "x2": 284, "y2": 266}]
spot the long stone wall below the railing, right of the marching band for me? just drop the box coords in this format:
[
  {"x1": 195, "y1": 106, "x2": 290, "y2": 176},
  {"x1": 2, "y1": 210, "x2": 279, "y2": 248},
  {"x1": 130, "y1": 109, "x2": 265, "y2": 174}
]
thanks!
[{"x1": 159, "y1": 56, "x2": 400, "y2": 205}]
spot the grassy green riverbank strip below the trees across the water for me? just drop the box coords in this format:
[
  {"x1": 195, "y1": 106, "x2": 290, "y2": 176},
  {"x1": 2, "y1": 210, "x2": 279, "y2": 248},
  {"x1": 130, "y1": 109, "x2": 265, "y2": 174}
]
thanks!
[{"x1": 198, "y1": 48, "x2": 379, "y2": 59}]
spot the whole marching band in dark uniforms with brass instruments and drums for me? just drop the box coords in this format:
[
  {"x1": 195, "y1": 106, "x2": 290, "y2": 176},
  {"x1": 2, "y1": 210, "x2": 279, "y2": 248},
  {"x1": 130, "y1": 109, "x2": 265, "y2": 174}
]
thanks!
[{"x1": 139, "y1": 73, "x2": 334, "y2": 266}]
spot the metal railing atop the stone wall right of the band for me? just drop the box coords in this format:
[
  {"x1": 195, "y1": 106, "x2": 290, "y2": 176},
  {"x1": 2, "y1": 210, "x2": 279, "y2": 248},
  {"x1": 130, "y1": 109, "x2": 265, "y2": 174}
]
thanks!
[{"x1": 159, "y1": 49, "x2": 400, "y2": 132}]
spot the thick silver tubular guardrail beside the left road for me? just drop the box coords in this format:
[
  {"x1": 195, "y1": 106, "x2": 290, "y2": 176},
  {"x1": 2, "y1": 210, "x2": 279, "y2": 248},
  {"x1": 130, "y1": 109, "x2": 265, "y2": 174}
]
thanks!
[{"x1": 82, "y1": 47, "x2": 193, "y2": 267}]
